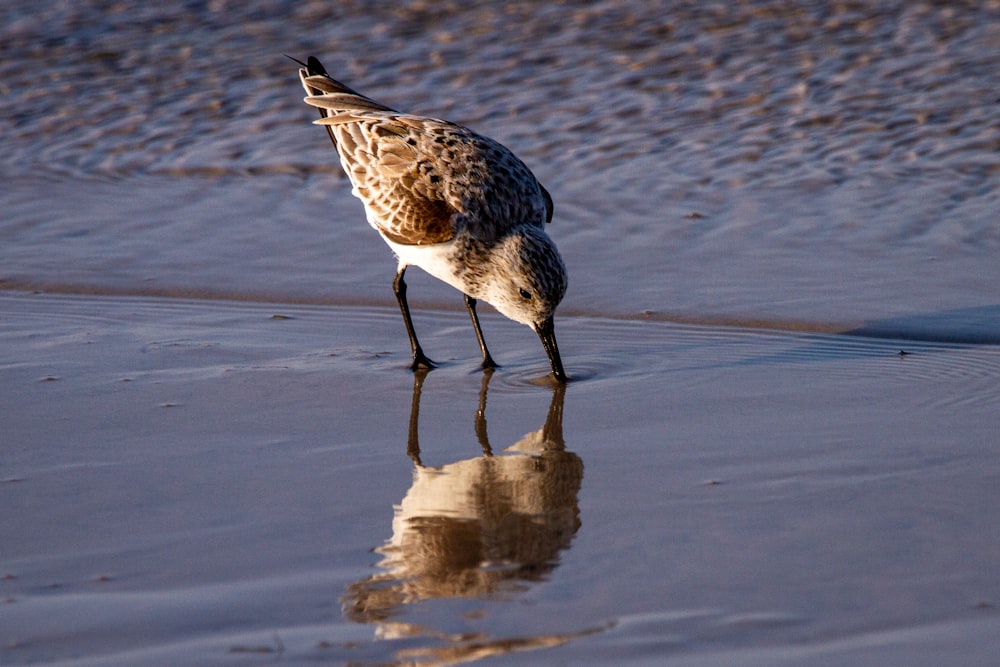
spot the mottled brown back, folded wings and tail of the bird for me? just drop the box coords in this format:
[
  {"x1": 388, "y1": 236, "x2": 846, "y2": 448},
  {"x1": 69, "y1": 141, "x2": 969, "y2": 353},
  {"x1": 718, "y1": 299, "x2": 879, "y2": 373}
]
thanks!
[{"x1": 300, "y1": 58, "x2": 552, "y2": 245}]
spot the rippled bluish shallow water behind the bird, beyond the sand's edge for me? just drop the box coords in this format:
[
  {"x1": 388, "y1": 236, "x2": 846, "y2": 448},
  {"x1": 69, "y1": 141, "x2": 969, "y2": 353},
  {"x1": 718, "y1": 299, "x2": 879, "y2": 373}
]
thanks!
[{"x1": 0, "y1": 1, "x2": 1000, "y2": 334}]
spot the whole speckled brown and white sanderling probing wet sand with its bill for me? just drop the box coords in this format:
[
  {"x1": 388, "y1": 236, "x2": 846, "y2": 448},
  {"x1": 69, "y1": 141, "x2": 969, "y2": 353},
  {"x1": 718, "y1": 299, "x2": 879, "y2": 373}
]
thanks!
[{"x1": 293, "y1": 56, "x2": 566, "y2": 382}]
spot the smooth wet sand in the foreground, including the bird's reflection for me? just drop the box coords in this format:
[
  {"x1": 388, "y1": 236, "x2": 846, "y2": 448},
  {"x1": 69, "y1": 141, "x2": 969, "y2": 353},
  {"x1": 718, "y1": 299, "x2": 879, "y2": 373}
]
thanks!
[{"x1": 0, "y1": 291, "x2": 1000, "y2": 665}]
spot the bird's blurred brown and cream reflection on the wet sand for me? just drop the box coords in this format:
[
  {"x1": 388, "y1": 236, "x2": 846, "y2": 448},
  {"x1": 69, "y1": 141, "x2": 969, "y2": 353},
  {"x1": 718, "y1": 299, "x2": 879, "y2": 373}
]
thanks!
[{"x1": 344, "y1": 372, "x2": 583, "y2": 638}]
